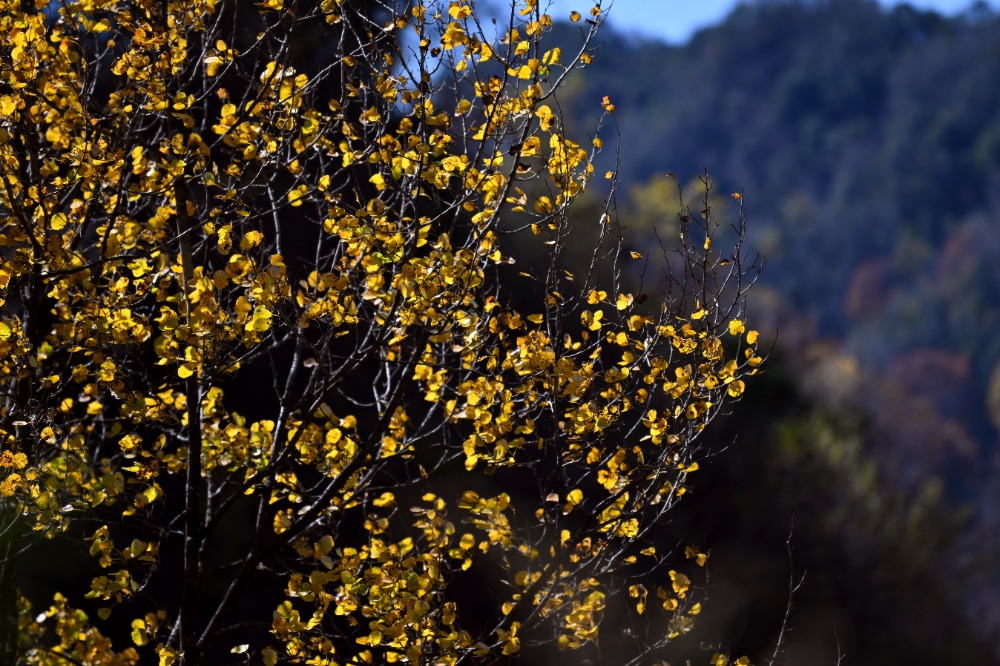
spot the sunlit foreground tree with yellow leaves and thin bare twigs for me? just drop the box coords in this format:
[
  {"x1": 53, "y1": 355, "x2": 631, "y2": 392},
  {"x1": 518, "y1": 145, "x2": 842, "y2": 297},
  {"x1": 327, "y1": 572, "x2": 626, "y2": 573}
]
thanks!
[{"x1": 0, "y1": 0, "x2": 761, "y2": 665}]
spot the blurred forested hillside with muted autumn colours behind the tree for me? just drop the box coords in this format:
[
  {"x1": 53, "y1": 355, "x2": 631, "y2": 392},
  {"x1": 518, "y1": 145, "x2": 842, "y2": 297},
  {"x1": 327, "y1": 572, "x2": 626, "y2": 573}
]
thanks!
[{"x1": 550, "y1": 0, "x2": 1000, "y2": 664}]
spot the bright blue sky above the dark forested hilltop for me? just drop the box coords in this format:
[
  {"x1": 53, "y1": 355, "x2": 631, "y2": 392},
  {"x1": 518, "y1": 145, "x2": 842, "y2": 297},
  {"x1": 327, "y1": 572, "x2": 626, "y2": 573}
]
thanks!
[{"x1": 539, "y1": 0, "x2": 998, "y2": 44}]
